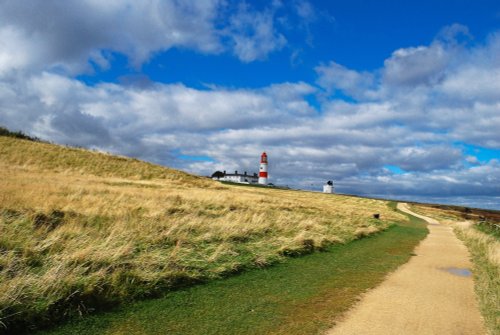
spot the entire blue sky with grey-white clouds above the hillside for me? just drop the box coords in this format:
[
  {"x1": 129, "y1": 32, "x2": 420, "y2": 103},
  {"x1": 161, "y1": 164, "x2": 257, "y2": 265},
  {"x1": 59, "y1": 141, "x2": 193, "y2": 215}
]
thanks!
[{"x1": 0, "y1": 0, "x2": 500, "y2": 209}]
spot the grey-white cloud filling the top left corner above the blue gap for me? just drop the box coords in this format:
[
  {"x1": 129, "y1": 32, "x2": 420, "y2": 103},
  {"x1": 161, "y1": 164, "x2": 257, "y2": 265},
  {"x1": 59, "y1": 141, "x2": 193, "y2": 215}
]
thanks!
[{"x1": 0, "y1": 0, "x2": 296, "y2": 75}]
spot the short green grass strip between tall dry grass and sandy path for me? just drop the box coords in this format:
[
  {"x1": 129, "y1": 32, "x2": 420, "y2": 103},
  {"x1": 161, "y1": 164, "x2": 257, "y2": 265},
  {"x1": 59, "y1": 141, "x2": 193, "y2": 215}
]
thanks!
[{"x1": 40, "y1": 218, "x2": 427, "y2": 335}]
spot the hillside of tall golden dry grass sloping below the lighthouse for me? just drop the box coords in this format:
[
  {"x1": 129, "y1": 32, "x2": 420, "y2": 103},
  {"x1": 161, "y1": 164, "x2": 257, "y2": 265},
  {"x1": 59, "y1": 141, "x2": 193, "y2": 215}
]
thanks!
[{"x1": 0, "y1": 136, "x2": 406, "y2": 331}]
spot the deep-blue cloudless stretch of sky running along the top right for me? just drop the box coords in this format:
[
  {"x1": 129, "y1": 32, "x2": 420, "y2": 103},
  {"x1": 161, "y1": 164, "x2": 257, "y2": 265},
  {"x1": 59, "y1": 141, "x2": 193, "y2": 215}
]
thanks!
[{"x1": 74, "y1": 0, "x2": 500, "y2": 88}]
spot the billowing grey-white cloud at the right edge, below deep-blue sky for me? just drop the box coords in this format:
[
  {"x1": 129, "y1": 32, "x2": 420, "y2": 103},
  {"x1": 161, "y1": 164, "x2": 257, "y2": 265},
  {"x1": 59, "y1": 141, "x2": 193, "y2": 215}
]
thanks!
[{"x1": 316, "y1": 25, "x2": 500, "y2": 148}]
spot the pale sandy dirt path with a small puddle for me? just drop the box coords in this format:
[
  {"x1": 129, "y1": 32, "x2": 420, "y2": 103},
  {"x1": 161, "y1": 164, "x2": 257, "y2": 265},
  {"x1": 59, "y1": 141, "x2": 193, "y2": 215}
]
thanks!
[{"x1": 326, "y1": 204, "x2": 486, "y2": 335}]
